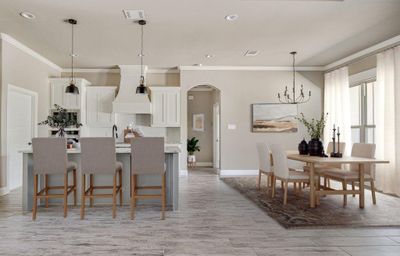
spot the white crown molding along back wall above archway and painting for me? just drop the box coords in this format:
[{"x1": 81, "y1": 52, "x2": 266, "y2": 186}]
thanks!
[{"x1": 178, "y1": 66, "x2": 325, "y2": 71}]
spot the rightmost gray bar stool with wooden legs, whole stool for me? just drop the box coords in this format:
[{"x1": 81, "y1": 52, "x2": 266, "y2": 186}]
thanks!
[{"x1": 131, "y1": 137, "x2": 166, "y2": 220}]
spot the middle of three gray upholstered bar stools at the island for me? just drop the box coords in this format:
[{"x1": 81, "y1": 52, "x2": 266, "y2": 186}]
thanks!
[{"x1": 80, "y1": 138, "x2": 122, "y2": 219}]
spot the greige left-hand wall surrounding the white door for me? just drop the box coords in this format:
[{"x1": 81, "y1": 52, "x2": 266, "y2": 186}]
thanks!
[{"x1": 0, "y1": 40, "x2": 61, "y2": 188}]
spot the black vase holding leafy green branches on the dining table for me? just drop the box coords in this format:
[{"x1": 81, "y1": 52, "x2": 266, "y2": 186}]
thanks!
[{"x1": 296, "y1": 113, "x2": 328, "y2": 156}]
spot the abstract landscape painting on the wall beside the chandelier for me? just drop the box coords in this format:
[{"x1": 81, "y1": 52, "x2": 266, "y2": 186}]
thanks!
[{"x1": 252, "y1": 103, "x2": 297, "y2": 132}]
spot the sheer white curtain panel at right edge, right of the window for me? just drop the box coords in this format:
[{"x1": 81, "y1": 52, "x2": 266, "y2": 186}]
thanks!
[{"x1": 375, "y1": 46, "x2": 400, "y2": 195}]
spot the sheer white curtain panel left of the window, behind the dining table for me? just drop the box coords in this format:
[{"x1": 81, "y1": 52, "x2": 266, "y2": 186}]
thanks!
[{"x1": 324, "y1": 67, "x2": 351, "y2": 155}]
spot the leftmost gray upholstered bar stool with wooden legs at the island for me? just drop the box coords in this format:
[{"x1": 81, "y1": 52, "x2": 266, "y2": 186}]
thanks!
[{"x1": 32, "y1": 138, "x2": 77, "y2": 220}]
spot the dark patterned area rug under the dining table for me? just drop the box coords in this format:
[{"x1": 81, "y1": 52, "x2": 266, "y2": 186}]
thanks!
[{"x1": 221, "y1": 177, "x2": 400, "y2": 228}]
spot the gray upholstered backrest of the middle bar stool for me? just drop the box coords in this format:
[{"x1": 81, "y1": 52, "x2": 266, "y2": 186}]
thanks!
[{"x1": 80, "y1": 137, "x2": 117, "y2": 174}]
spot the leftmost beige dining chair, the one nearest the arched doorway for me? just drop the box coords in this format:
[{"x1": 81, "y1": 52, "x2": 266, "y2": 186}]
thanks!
[{"x1": 257, "y1": 142, "x2": 274, "y2": 192}]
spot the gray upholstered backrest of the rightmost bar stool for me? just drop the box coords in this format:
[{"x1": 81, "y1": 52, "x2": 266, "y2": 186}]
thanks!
[{"x1": 131, "y1": 137, "x2": 165, "y2": 174}]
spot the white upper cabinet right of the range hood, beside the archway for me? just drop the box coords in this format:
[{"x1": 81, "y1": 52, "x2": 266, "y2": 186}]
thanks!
[{"x1": 150, "y1": 86, "x2": 181, "y2": 127}]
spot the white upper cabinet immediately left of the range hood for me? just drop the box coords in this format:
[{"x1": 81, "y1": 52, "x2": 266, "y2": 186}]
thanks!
[{"x1": 86, "y1": 86, "x2": 117, "y2": 127}]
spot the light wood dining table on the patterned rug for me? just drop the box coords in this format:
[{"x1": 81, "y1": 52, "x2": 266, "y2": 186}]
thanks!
[{"x1": 287, "y1": 151, "x2": 389, "y2": 208}]
